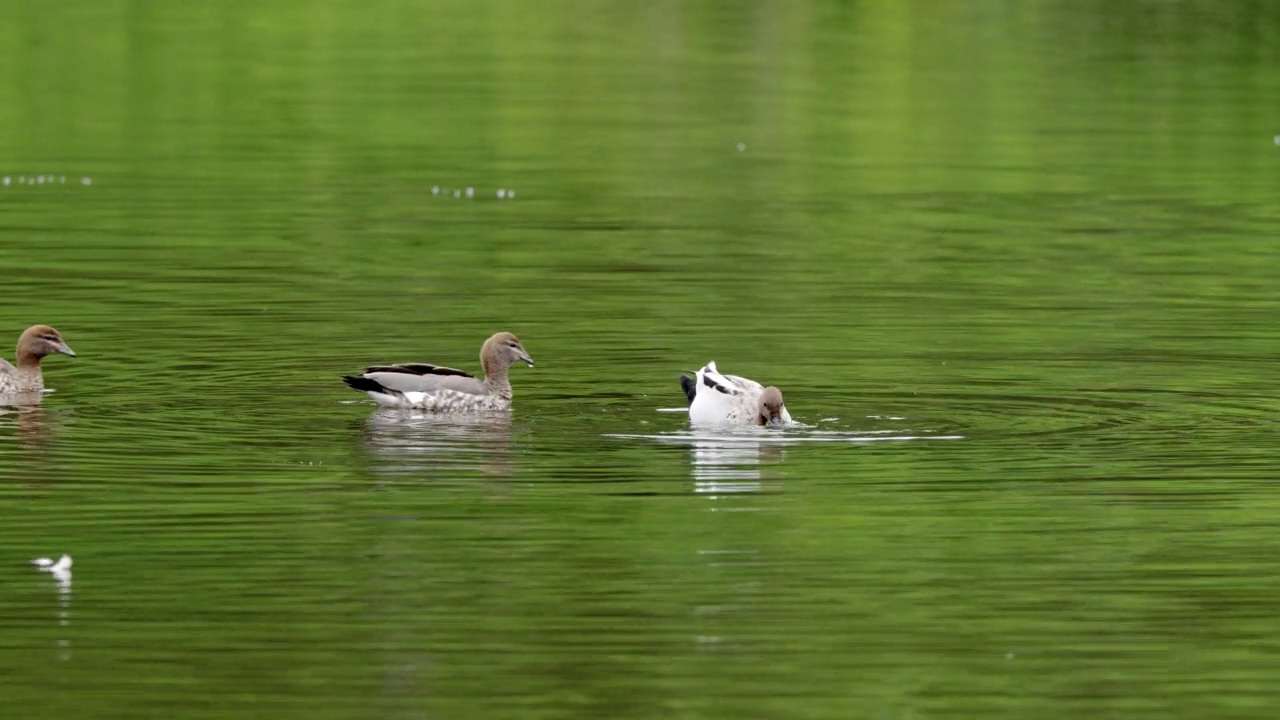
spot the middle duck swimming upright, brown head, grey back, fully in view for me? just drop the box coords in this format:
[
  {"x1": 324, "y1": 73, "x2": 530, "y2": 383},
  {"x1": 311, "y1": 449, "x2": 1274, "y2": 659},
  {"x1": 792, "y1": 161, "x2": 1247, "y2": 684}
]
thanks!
[{"x1": 342, "y1": 332, "x2": 534, "y2": 413}]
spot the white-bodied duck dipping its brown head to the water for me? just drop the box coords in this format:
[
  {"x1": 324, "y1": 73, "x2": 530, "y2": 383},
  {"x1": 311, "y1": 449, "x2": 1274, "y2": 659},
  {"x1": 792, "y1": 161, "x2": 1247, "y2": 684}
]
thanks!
[{"x1": 680, "y1": 360, "x2": 791, "y2": 427}]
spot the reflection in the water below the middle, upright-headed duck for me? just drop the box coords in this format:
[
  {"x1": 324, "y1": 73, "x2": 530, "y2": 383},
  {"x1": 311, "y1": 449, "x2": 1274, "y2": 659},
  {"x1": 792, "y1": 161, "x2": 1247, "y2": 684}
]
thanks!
[{"x1": 355, "y1": 407, "x2": 511, "y2": 477}]
